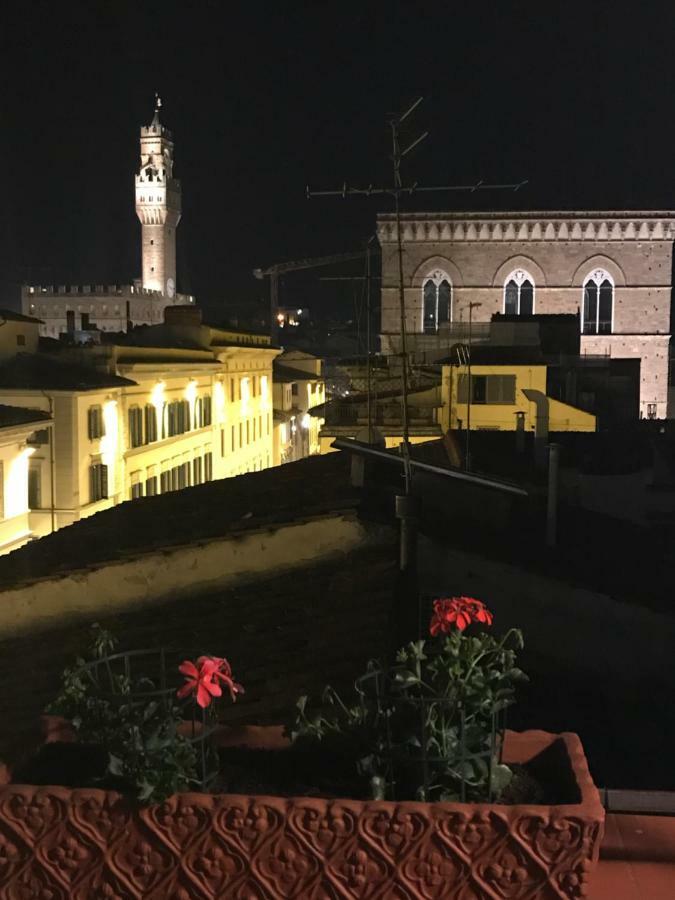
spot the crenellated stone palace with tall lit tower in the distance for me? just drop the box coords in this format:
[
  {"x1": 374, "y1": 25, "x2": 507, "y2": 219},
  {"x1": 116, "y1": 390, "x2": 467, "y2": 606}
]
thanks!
[{"x1": 21, "y1": 98, "x2": 195, "y2": 340}]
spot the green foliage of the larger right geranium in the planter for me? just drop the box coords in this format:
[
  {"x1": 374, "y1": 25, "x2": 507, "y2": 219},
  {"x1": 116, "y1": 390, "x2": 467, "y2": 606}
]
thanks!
[{"x1": 291, "y1": 629, "x2": 526, "y2": 800}]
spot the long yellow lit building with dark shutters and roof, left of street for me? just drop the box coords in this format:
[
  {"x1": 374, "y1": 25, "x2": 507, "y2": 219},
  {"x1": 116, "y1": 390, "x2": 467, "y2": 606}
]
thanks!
[{"x1": 0, "y1": 308, "x2": 280, "y2": 536}]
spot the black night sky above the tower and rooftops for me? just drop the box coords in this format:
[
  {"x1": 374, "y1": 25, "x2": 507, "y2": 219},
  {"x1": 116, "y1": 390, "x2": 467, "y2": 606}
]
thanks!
[{"x1": 0, "y1": 0, "x2": 675, "y2": 317}]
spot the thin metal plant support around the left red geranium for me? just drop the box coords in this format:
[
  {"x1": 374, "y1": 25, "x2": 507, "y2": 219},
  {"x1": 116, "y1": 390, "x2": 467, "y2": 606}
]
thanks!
[{"x1": 77, "y1": 647, "x2": 218, "y2": 791}]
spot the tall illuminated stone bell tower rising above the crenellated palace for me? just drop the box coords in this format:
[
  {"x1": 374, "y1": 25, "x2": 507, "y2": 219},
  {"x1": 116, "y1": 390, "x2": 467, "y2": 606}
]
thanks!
[{"x1": 136, "y1": 94, "x2": 181, "y2": 298}]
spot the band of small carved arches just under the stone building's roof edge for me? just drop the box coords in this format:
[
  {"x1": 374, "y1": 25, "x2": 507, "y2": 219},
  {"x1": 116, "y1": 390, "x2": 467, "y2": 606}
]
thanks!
[{"x1": 377, "y1": 218, "x2": 675, "y2": 243}]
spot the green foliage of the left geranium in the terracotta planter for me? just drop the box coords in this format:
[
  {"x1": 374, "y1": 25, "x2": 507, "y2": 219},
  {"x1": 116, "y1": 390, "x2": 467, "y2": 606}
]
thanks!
[{"x1": 47, "y1": 624, "x2": 197, "y2": 803}]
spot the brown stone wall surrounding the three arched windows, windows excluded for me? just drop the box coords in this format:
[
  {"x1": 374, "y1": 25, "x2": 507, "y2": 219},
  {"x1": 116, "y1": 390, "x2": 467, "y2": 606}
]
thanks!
[{"x1": 379, "y1": 213, "x2": 673, "y2": 418}]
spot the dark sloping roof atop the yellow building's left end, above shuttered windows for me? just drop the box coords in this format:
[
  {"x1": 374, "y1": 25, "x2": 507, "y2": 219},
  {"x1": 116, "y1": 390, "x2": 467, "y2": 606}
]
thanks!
[{"x1": 0, "y1": 353, "x2": 136, "y2": 391}]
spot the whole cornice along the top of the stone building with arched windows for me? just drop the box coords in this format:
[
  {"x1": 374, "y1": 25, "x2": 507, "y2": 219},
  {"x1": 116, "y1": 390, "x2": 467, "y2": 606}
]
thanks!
[{"x1": 377, "y1": 210, "x2": 675, "y2": 244}]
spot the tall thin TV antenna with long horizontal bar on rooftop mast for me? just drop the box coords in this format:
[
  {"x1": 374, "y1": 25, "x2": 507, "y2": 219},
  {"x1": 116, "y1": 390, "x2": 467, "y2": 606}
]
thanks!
[{"x1": 306, "y1": 97, "x2": 527, "y2": 570}]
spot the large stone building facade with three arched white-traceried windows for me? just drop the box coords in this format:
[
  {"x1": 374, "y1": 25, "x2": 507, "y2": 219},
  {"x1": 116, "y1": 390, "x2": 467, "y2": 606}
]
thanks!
[{"x1": 378, "y1": 211, "x2": 675, "y2": 418}]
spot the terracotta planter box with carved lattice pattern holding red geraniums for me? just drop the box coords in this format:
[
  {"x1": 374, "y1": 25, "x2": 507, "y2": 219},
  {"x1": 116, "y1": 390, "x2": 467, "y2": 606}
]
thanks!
[{"x1": 0, "y1": 729, "x2": 604, "y2": 900}]
